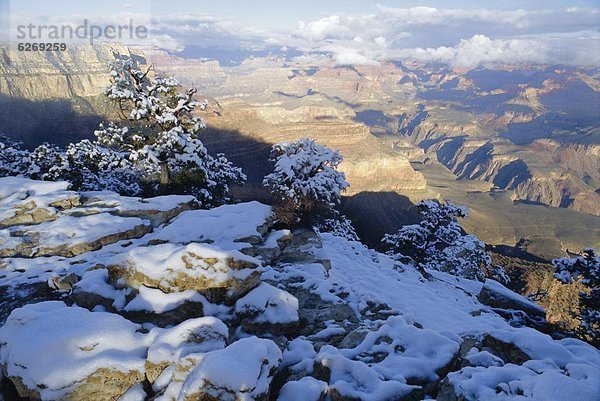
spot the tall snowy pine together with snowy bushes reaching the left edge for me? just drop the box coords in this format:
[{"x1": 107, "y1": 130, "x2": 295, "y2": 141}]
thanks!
[{"x1": 0, "y1": 59, "x2": 246, "y2": 207}]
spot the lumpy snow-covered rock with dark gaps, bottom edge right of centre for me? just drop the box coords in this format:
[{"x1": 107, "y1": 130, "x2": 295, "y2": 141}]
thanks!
[{"x1": 315, "y1": 316, "x2": 460, "y2": 400}]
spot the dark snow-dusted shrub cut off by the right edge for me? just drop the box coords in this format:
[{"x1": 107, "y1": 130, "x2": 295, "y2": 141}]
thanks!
[{"x1": 552, "y1": 249, "x2": 600, "y2": 345}]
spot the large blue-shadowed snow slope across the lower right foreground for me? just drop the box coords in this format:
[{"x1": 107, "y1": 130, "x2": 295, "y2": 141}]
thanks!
[{"x1": 263, "y1": 234, "x2": 600, "y2": 400}]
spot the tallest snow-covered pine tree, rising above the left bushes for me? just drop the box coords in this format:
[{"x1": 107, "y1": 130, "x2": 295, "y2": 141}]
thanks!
[{"x1": 96, "y1": 59, "x2": 246, "y2": 206}]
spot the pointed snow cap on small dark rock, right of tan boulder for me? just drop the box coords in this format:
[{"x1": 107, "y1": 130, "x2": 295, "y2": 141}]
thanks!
[{"x1": 235, "y1": 283, "x2": 298, "y2": 324}]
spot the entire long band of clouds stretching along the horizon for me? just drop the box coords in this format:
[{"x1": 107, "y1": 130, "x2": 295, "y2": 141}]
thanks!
[{"x1": 7, "y1": 5, "x2": 600, "y2": 66}]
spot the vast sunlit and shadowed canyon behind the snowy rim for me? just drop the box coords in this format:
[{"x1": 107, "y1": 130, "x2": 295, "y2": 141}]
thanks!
[{"x1": 0, "y1": 44, "x2": 600, "y2": 259}]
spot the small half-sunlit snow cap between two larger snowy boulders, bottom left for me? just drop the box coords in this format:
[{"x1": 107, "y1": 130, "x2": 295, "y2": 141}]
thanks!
[{"x1": 147, "y1": 316, "x2": 229, "y2": 364}]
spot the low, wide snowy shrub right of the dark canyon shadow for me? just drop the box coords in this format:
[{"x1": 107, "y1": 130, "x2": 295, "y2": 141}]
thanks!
[{"x1": 382, "y1": 200, "x2": 491, "y2": 281}]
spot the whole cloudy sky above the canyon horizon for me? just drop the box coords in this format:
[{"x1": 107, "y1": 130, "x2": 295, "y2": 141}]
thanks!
[{"x1": 0, "y1": 0, "x2": 600, "y2": 67}]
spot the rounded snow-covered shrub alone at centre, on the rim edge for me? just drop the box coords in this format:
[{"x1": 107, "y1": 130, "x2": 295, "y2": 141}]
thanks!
[{"x1": 263, "y1": 138, "x2": 348, "y2": 224}]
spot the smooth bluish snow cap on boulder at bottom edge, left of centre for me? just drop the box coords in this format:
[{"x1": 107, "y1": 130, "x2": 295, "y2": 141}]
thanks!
[{"x1": 182, "y1": 337, "x2": 281, "y2": 401}]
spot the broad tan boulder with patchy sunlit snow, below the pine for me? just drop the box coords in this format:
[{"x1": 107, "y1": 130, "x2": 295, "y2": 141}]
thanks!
[{"x1": 108, "y1": 243, "x2": 260, "y2": 303}]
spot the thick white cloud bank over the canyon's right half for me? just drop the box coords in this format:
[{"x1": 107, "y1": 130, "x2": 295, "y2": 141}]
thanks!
[{"x1": 284, "y1": 6, "x2": 600, "y2": 67}]
